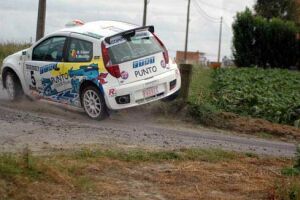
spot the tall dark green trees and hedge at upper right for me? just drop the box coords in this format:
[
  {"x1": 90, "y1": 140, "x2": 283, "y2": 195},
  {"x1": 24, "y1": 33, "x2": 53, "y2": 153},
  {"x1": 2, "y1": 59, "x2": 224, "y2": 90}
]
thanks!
[{"x1": 232, "y1": 0, "x2": 300, "y2": 69}]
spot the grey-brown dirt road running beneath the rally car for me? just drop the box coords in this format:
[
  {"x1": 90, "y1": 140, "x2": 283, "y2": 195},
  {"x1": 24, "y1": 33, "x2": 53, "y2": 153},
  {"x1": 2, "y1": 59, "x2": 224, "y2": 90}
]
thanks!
[{"x1": 0, "y1": 87, "x2": 295, "y2": 157}]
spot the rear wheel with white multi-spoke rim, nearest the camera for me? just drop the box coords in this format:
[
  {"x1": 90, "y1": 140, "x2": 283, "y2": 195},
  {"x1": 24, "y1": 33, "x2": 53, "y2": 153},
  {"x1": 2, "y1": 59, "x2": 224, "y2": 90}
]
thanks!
[{"x1": 81, "y1": 86, "x2": 108, "y2": 120}]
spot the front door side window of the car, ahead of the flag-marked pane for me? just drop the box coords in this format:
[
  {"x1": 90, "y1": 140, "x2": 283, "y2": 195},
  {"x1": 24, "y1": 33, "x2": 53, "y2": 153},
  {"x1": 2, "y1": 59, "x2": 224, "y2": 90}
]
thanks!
[{"x1": 32, "y1": 37, "x2": 66, "y2": 62}]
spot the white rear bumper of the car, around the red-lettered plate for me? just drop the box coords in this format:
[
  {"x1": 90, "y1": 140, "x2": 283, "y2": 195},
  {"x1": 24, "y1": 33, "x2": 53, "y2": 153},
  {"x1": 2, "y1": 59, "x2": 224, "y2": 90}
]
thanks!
[{"x1": 104, "y1": 69, "x2": 181, "y2": 110}]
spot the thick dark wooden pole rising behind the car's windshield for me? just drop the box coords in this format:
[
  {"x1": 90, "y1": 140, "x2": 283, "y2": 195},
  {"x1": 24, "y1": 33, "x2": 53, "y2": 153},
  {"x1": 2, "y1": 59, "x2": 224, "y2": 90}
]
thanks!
[{"x1": 35, "y1": 0, "x2": 46, "y2": 41}]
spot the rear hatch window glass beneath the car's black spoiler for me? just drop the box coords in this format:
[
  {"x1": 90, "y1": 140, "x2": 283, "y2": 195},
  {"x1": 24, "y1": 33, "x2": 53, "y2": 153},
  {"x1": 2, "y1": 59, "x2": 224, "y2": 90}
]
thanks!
[{"x1": 109, "y1": 33, "x2": 163, "y2": 64}]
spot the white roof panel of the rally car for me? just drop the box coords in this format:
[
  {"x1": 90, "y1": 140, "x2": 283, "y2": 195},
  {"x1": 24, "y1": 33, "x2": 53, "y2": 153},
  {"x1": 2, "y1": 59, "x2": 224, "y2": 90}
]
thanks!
[{"x1": 58, "y1": 21, "x2": 138, "y2": 39}]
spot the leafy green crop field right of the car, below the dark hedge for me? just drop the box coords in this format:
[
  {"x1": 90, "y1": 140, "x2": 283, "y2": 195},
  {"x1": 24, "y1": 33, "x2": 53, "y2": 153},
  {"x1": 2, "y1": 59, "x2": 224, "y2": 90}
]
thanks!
[{"x1": 190, "y1": 68, "x2": 300, "y2": 124}]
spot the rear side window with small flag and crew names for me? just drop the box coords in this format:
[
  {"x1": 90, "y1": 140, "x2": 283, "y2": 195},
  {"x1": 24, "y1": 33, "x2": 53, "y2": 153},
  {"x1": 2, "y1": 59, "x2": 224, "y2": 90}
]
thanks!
[{"x1": 67, "y1": 38, "x2": 93, "y2": 62}]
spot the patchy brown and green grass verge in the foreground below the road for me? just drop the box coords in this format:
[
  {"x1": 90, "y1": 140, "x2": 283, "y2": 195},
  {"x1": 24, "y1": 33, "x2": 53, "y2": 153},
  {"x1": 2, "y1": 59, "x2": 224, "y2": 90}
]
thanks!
[{"x1": 0, "y1": 149, "x2": 298, "y2": 200}]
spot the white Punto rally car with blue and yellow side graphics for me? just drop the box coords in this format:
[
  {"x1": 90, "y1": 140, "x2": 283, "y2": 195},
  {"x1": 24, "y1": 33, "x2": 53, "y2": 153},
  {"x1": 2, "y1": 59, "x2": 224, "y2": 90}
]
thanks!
[{"x1": 1, "y1": 21, "x2": 181, "y2": 119}]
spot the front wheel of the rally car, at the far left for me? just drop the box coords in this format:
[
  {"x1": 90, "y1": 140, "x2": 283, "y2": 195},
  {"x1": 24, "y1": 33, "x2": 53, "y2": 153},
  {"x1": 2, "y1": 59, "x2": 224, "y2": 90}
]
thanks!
[{"x1": 4, "y1": 71, "x2": 24, "y2": 101}]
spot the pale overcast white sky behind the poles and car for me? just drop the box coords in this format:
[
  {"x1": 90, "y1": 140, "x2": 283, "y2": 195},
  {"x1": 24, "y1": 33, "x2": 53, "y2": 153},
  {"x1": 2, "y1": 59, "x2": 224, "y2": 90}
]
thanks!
[{"x1": 0, "y1": 0, "x2": 255, "y2": 60}]
